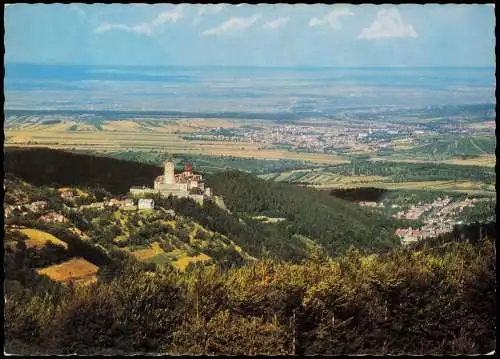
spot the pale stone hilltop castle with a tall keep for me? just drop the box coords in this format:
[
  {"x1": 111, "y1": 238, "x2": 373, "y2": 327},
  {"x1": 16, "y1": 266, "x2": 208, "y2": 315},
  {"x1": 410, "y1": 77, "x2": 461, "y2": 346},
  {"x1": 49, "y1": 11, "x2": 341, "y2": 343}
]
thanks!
[{"x1": 130, "y1": 160, "x2": 212, "y2": 202}]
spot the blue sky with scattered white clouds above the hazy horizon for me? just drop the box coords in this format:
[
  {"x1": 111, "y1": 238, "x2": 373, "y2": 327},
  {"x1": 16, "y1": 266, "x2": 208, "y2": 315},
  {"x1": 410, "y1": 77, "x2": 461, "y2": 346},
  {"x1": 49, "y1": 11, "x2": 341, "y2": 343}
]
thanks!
[{"x1": 4, "y1": 4, "x2": 495, "y2": 67}]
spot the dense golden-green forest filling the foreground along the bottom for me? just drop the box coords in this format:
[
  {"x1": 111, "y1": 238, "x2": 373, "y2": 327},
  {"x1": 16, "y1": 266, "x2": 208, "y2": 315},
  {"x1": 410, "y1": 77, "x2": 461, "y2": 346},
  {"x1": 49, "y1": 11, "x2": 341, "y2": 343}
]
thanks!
[{"x1": 4, "y1": 224, "x2": 496, "y2": 355}]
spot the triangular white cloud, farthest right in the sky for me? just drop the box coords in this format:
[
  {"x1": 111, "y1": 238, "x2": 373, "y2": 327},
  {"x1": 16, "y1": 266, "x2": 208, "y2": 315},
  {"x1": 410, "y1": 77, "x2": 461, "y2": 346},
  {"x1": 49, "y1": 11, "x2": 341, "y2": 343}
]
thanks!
[{"x1": 358, "y1": 7, "x2": 418, "y2": 39}]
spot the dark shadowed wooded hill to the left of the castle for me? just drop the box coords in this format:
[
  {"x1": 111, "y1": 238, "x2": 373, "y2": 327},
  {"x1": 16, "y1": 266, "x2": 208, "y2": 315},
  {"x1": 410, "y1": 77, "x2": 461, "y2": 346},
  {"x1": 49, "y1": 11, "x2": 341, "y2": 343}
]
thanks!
[{"x1": 4, "y1": 148, "x2": 163, "y2": 194}]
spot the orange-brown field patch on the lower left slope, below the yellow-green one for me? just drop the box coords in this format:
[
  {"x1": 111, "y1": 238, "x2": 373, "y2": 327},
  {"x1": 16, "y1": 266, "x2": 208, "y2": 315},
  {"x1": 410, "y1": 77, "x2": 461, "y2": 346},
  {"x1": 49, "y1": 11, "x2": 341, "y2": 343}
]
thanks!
[{"x1": 37, "y1": 258, "x2": 99, "y2": 284}]
